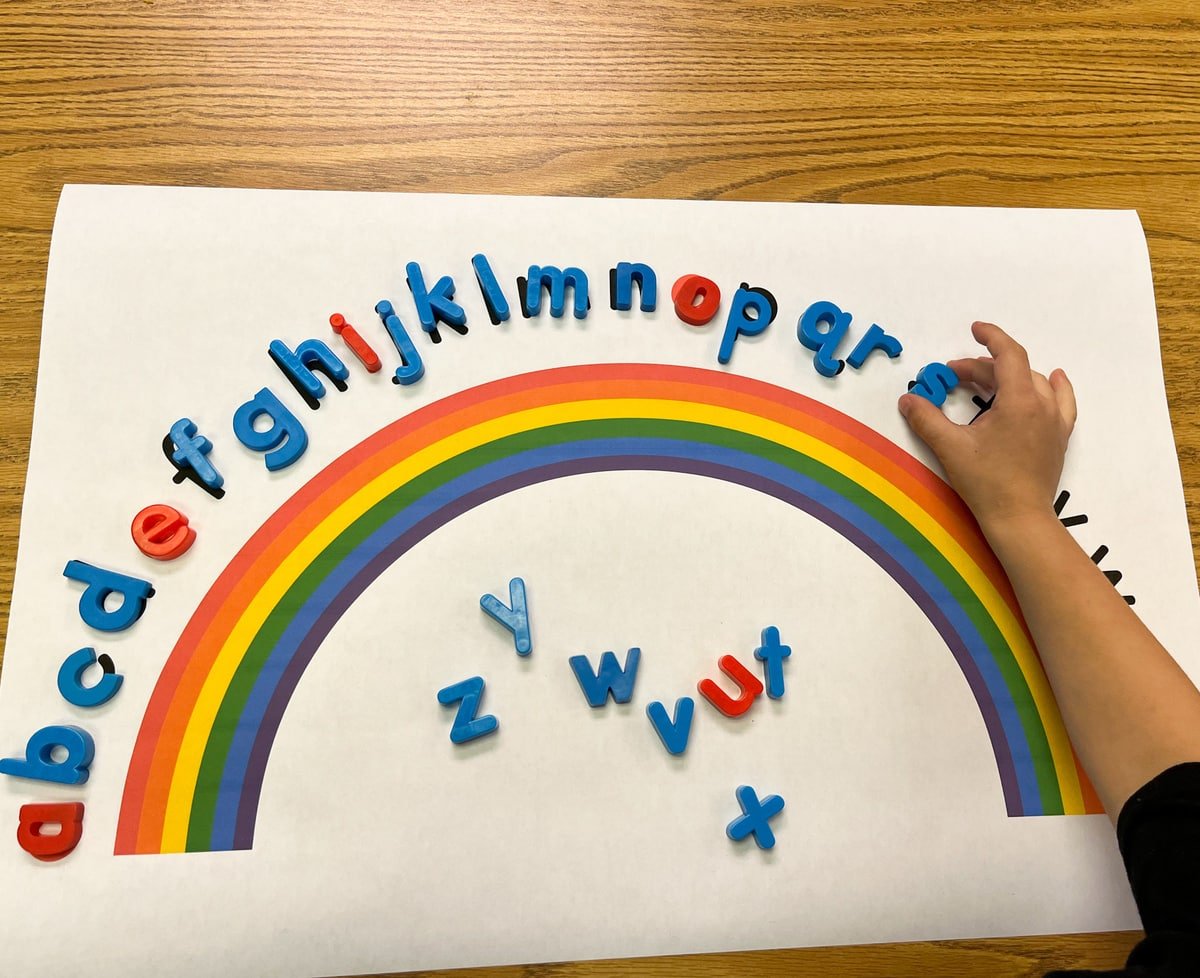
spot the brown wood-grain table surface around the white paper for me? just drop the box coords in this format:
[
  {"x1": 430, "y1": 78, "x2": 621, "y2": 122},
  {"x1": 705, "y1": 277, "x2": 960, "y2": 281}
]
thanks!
[{"x1": 0, "y1": 0, "x2": 1200, "y2": 978}]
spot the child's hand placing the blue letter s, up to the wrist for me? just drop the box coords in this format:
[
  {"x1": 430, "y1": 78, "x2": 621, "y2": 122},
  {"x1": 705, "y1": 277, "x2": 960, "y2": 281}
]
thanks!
[{"x1": 899, "y1": 323, "x2": 1075, "y2": 532}]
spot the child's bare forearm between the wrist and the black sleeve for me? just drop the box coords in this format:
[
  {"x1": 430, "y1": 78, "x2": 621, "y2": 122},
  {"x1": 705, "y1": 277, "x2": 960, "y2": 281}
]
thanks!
[{"x1": 984, "y1": 508, "x2": 1200, "y2": 820}]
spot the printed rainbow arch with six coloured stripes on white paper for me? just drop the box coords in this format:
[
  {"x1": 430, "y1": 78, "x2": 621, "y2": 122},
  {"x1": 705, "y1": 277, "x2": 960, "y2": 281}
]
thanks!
[{"x1": 115, "y1": 365, "x2": 1102, "y2": 853}]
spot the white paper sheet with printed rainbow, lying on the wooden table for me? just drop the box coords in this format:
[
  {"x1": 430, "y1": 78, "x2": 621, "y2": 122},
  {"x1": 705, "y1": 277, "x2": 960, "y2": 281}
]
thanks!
[{"x1": 0, "y1": 187, "x2": 1200, "y2": 978}]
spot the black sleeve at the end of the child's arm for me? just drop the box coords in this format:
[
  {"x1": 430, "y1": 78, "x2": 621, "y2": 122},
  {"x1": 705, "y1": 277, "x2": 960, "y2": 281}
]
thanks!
[{"x1": 1117, "y1": 763, "x2": 1200, "y2": 978}]
